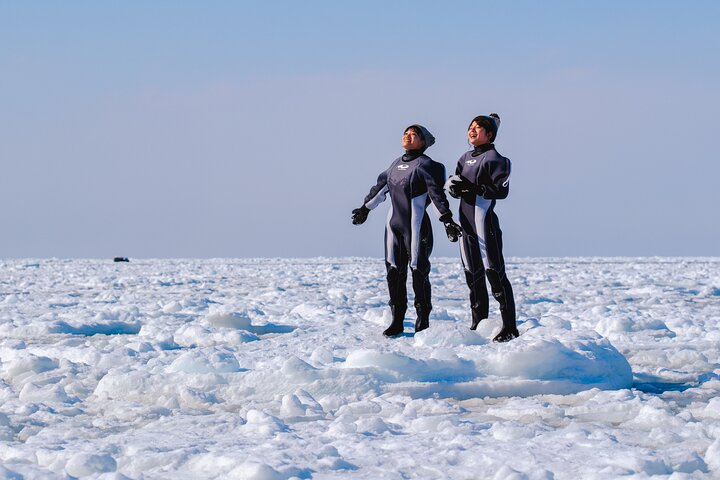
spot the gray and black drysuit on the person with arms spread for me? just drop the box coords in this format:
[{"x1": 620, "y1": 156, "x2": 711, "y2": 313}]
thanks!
[{"x1": 364, "y1": 151, "x2": 452, "y2": 314}]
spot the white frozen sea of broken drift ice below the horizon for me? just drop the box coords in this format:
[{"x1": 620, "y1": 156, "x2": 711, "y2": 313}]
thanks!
[{"x1": 0, "y1": 258, "x2": 720, "y2": 480}]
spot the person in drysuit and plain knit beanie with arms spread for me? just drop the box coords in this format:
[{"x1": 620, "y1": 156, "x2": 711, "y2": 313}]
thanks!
[{"x1": 352, "y1": 125, "x2": 461, "y2": 337}]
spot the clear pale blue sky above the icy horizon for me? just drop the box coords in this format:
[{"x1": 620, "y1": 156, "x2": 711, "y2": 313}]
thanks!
[{"x1": 0, "y1": 1, "x2": 720, "y2": 258}]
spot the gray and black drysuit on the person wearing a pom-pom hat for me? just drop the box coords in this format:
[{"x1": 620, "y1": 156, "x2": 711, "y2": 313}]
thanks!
[{"x1": 455, "y1": 144, "x2": 515, "y2": 328}]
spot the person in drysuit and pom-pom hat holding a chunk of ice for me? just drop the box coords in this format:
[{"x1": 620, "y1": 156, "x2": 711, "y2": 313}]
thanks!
[{"x1": 446, "y1": 113, "x2": 519, "y2": 342}]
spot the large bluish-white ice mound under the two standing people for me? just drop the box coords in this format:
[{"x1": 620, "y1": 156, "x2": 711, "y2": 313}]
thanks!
[{"x1": 343, "y1": 317, "x2": 633, "y2": 399}]
